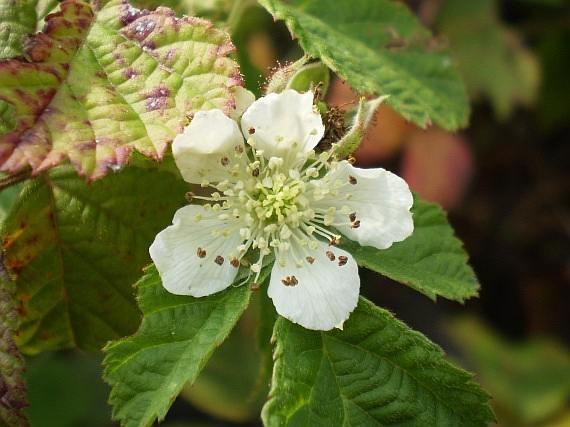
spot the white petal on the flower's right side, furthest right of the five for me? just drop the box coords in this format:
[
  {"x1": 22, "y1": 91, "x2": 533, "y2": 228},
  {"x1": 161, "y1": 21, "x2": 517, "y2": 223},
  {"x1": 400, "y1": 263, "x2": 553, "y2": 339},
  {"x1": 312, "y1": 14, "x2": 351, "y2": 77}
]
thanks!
[{"x1": 315, "y1": 161, "x2": 414, "y2": 249}]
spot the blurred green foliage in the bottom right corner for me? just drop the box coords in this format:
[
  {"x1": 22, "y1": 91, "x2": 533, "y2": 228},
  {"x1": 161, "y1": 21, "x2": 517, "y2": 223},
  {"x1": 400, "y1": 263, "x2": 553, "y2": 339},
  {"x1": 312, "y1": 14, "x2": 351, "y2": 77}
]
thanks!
[{"x1": 449, "y1": 318, "x2": 570, "y2": 426}]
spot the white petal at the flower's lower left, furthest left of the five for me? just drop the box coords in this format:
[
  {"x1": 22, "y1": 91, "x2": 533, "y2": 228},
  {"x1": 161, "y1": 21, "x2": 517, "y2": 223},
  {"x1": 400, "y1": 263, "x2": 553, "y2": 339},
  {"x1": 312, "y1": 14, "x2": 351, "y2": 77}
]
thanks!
[{"x1": 149, "y1": 205, "x2": 242, "y2": 297}]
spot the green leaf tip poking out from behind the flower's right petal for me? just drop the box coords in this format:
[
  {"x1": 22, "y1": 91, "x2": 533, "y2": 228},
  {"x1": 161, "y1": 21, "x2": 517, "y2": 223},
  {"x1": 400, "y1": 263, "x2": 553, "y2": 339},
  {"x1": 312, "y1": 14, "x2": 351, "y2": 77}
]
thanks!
[{"x1": 341, "y1": 197, "x2": 479, "y2": 302}]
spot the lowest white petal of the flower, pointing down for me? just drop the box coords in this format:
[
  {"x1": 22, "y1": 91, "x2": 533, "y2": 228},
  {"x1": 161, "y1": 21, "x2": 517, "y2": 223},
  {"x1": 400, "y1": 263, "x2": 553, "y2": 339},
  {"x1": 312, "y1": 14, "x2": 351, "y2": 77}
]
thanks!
[{"x1": 268, "y1": 241, "x2": 360, "y2": 331}]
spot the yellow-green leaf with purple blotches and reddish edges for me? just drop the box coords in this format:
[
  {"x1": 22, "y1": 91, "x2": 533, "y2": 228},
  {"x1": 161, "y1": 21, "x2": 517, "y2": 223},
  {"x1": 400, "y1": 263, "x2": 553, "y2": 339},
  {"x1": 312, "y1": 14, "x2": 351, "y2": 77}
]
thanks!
[{"x1": 0, "y1": 0, "x2": 241, "y2": 179}]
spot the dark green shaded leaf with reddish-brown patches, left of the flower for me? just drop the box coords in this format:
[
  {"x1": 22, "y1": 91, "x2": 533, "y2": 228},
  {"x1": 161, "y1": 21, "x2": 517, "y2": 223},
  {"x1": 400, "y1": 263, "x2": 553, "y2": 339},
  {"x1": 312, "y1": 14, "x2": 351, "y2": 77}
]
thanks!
[{"x1": 1, "y1": 162, "x2": 187, "y2": 353}]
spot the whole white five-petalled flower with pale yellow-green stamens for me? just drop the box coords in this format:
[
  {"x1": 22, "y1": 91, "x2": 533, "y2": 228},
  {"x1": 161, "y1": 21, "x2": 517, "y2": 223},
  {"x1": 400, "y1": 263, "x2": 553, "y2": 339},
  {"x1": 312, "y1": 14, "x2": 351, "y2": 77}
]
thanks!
[{"x1": 150, "y1": 90, "x2": 413, "y2": 330}]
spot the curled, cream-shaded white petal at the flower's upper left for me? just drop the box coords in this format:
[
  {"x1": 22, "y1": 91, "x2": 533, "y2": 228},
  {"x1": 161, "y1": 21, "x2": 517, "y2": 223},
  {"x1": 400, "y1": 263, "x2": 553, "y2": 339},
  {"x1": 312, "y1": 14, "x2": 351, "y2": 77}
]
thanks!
[{"x1": 172, "y1": 110, "x2": 243, "y2": 184}]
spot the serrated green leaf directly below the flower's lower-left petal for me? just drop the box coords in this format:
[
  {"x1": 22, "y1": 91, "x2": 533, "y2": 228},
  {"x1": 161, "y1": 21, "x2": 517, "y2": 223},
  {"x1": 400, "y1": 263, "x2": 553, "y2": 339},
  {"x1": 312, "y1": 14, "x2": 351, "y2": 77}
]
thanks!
[{"x1": 104, "y1": 266, "x2": 251, "y2": 427}]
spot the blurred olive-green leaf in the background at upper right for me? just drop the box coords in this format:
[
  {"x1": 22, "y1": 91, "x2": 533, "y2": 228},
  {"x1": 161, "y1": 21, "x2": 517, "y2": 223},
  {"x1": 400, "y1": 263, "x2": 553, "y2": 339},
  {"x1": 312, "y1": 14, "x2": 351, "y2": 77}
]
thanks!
[{"x1": 439, "y1": 0, "x2": 539, "y2": 118}]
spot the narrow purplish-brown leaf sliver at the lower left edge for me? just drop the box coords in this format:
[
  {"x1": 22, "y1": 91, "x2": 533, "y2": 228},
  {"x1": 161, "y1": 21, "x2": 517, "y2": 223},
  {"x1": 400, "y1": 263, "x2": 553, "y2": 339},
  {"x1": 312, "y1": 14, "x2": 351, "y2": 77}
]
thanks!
[{"x1": 0, "y1": 276, "x2": 28, "y2": 427}]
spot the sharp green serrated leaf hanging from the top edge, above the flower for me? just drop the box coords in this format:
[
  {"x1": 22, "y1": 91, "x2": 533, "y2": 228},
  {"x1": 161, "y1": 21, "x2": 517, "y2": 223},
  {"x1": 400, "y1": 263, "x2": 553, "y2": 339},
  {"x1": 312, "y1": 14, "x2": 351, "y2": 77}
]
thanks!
[{"x1": 260, "y1": 0, "x2": 469, "y2": 130}]
